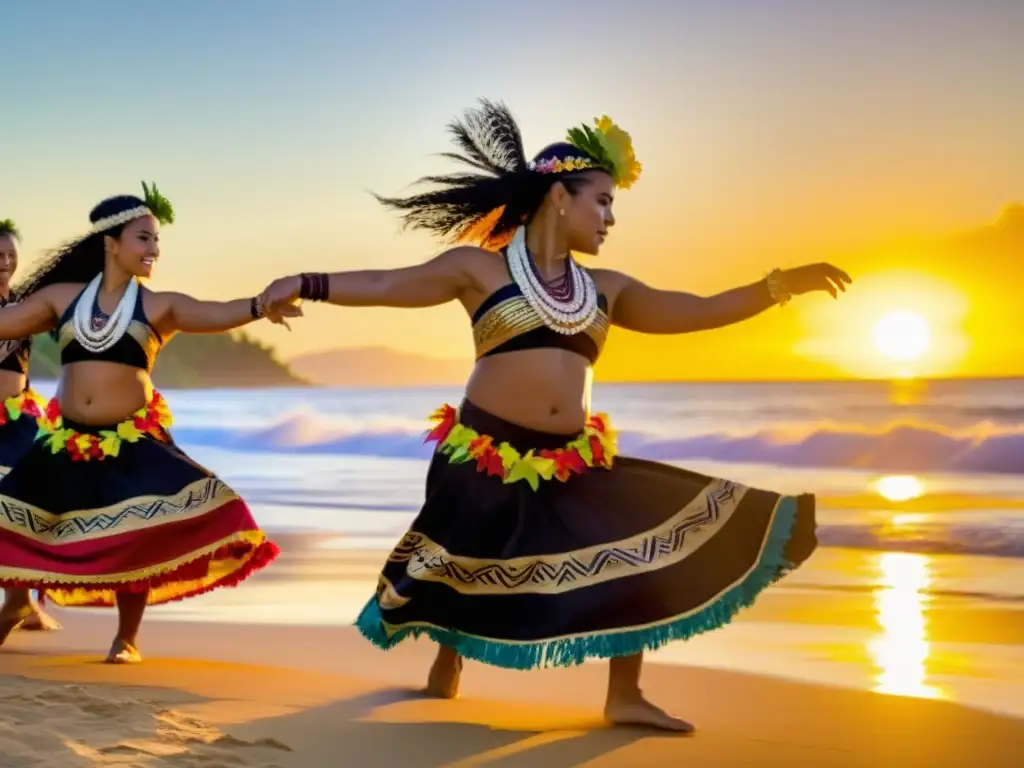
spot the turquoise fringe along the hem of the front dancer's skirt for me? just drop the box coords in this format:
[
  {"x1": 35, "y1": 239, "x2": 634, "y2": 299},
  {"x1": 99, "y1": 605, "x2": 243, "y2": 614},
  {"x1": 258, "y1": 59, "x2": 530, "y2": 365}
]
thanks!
[{"x1": 355, "y1": 497, "x2": 798, "y2": 670}]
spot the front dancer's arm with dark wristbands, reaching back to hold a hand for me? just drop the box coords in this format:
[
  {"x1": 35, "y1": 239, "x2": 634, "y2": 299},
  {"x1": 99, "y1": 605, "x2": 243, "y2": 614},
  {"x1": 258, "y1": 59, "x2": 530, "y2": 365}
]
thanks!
[{"x1": 260, "y1": 246, "x2": 481, "y2": 311}]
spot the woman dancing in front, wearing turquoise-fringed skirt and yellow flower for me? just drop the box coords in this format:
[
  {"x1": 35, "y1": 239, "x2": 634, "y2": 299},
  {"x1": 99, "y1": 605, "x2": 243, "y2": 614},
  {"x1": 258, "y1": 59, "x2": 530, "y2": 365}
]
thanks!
[{"x1": 261, "y1": 101, "x2": 850, "y2": 731}]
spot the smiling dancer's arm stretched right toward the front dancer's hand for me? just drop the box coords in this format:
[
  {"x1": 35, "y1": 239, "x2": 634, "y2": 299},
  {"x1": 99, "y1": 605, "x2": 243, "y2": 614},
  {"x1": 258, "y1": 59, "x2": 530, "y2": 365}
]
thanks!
[{"x1": 153, "y1": 292, "x2": 302, "y2": 337}]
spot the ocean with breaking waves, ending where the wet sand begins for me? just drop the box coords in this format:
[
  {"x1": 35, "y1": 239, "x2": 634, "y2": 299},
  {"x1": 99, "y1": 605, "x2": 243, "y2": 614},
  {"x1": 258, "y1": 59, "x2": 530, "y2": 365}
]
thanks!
[{"x1": 34, "y1": 380, "x2": 1024, "y2": 565}]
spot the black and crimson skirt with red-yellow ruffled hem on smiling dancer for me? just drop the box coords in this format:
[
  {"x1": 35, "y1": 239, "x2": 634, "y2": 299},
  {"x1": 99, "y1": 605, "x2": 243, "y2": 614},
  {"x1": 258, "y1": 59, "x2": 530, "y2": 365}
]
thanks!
[{"x1": 0, "y1": 397, "x2": 278, "y2": 606}]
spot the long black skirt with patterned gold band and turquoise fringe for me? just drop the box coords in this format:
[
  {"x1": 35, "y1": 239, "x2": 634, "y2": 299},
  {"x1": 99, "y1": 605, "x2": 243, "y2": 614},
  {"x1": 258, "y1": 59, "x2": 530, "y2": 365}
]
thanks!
[{"x1": 356, "y1": 402, "x2": 817, "y2": 669}]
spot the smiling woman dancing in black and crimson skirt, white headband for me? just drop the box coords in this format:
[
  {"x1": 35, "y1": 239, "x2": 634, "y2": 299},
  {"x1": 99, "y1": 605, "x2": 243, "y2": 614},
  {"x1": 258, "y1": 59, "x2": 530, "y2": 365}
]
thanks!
[{"x1": 0, "y1": 184, "x2": 299, "y2": 664}]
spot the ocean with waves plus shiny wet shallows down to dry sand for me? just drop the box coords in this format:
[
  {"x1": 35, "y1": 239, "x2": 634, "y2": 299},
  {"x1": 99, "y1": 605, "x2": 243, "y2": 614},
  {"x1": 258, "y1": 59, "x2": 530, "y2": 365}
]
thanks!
[{"x1": 25, "y1": 380, "x2": 1024, "y2": 717}]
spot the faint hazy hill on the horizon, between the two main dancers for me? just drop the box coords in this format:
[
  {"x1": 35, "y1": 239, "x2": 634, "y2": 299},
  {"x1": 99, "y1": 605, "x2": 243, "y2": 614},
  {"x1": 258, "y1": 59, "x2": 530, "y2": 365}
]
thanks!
[{"x1": 288, "y1": 347, "x2": 473, "y2": 387}]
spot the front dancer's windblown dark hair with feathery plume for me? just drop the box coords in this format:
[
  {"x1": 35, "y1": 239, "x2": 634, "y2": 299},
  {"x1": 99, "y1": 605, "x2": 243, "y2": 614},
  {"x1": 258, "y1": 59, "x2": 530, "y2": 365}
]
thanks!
[{"x1": 374, "y1": 99, "x2": 598, "y2": 249}]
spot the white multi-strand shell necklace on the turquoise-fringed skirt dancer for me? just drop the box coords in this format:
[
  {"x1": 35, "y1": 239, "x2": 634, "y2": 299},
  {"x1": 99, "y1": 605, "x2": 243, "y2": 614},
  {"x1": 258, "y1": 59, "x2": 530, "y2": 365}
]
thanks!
[{"x1": 508, "y1": 226, "x2": 597, "y2": 336}]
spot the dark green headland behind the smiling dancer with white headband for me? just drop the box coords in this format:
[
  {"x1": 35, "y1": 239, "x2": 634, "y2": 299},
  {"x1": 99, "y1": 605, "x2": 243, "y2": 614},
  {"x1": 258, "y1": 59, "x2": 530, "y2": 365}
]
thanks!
[{"x1": 30, "y1": 333, "x2": 309, "y2": 389}]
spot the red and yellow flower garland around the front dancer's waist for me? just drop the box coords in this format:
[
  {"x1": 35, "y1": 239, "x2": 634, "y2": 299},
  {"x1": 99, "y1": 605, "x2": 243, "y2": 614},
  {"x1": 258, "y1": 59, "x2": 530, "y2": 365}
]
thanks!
[{"x1": 425, "y1": 403, "x2": 617, "y2": 490}]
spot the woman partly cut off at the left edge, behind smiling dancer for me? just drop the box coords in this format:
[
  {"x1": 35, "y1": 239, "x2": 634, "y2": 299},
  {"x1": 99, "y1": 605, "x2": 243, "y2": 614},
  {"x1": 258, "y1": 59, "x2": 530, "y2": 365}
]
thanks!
[{"x1": 0, "y1": 219, "x2": 60, "y2": 631}]
